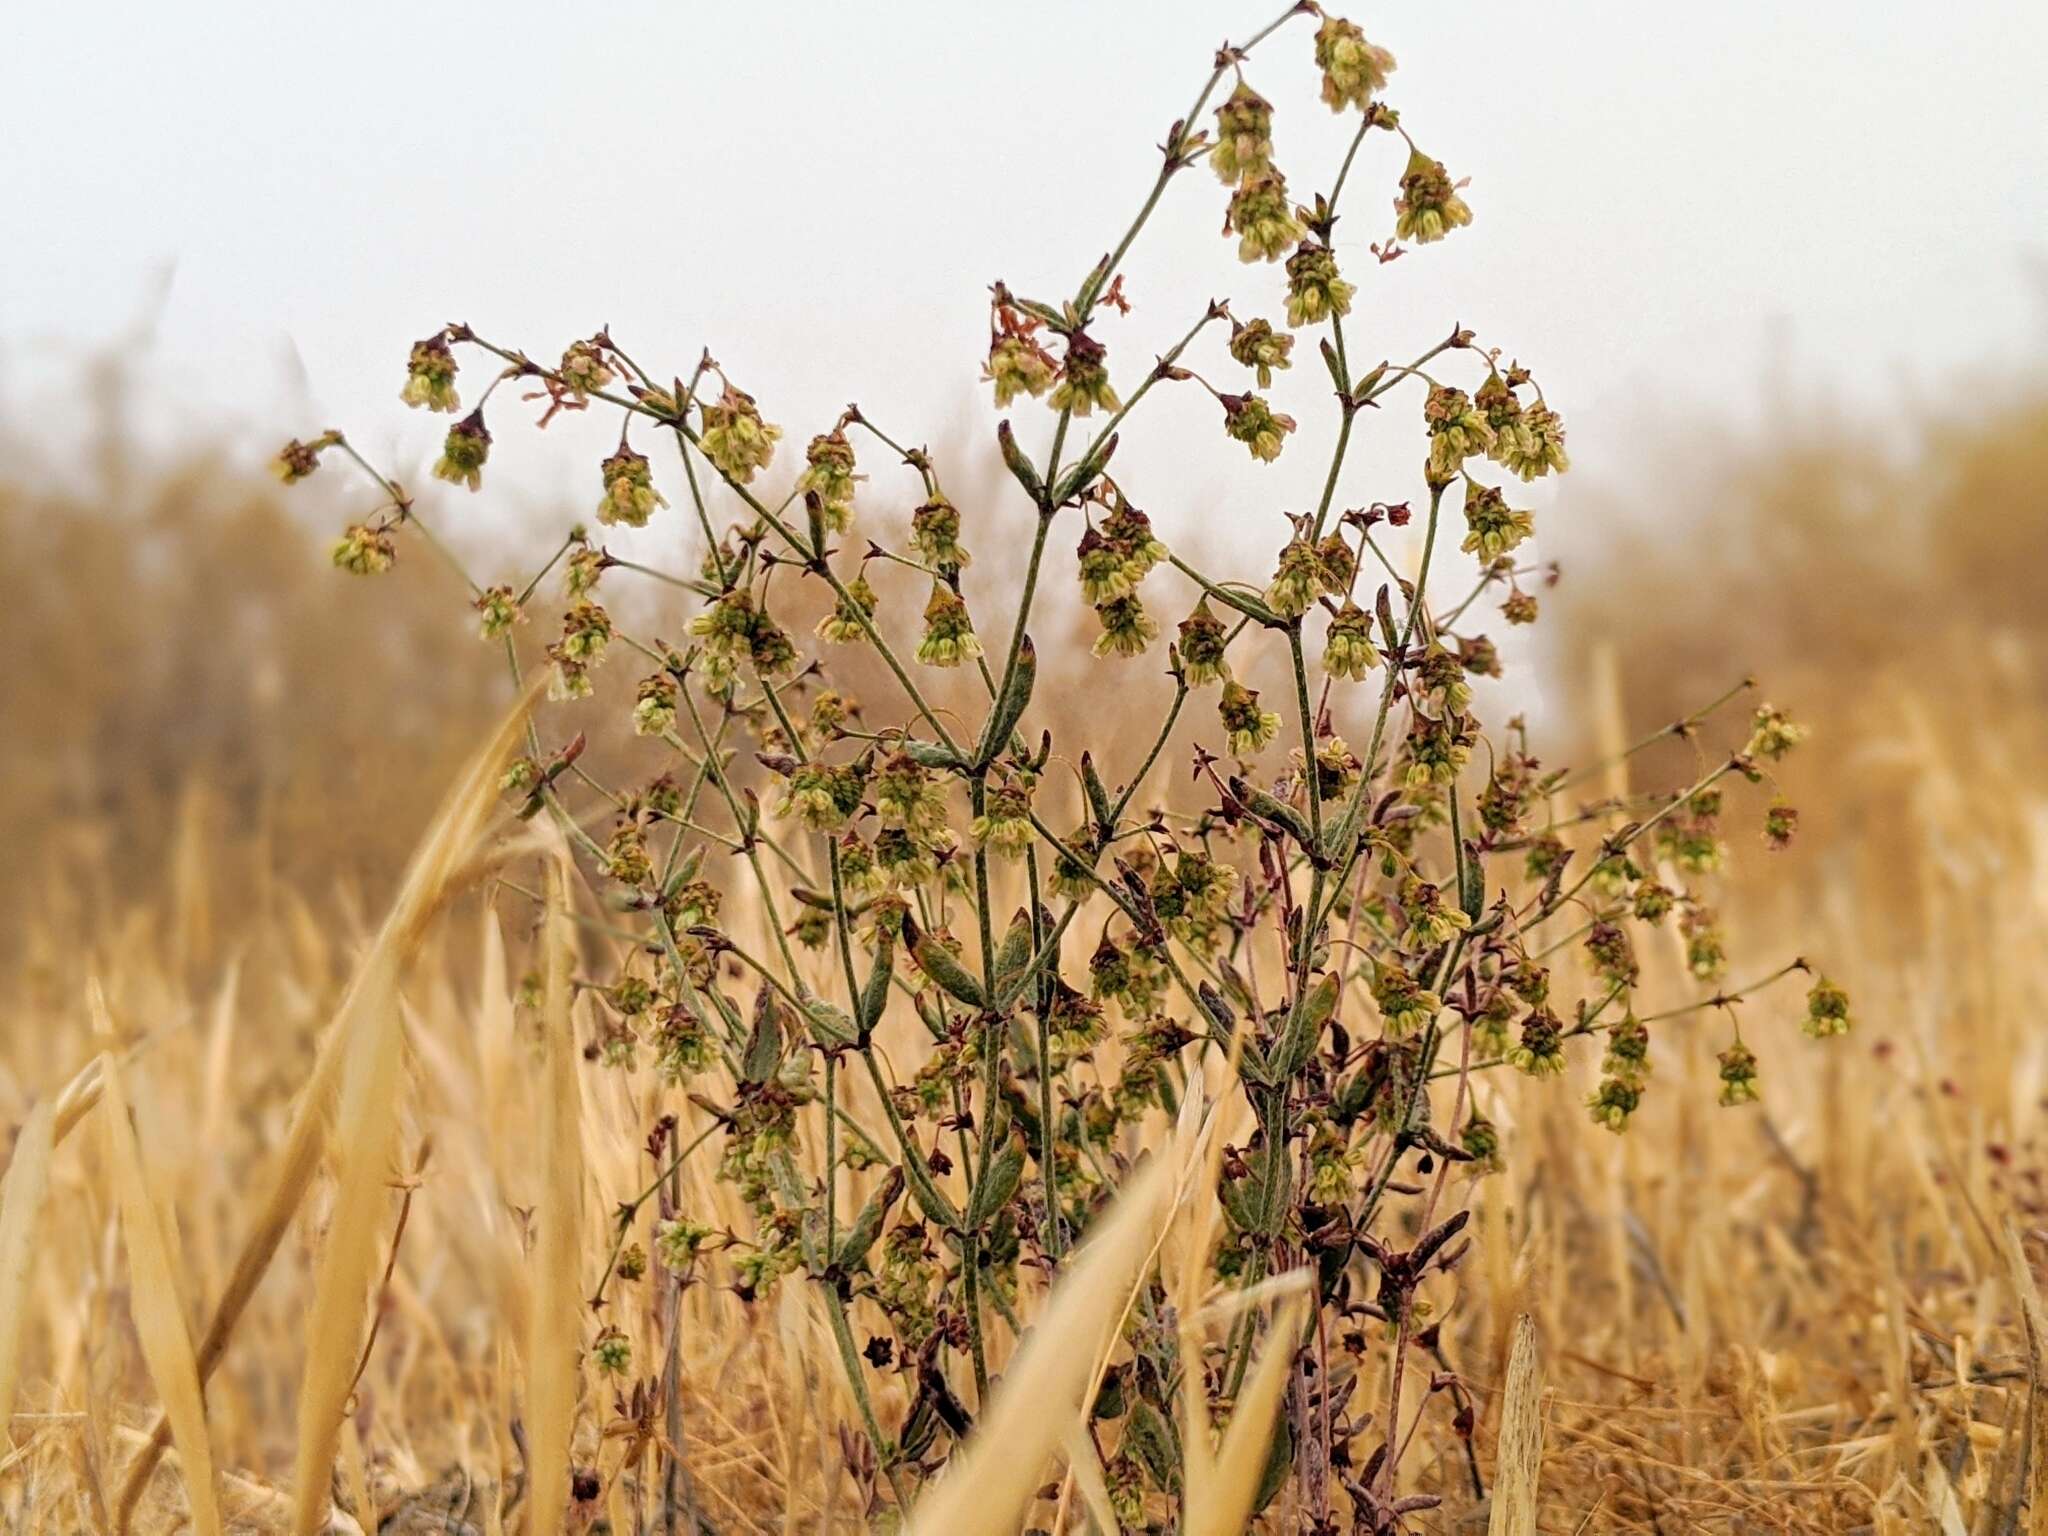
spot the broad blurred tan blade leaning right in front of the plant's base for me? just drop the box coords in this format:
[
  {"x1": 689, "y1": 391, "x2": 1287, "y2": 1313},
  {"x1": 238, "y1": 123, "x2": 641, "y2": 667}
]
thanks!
[{"x1": 909, "y1": 1157, "x2": 1174, "y2": 1536}]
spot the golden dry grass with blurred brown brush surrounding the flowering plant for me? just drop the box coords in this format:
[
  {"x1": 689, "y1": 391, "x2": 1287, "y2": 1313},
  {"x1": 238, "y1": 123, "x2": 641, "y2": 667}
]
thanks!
[{"x1": 0, "y1": 376, "x2": 2048, "y2": 1536}]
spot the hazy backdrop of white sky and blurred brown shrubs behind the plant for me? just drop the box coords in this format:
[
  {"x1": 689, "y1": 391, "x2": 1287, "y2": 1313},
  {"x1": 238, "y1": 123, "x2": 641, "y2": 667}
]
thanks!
[{"x1": 0, "y1": 0, "x2": 2048, "y2": 946}]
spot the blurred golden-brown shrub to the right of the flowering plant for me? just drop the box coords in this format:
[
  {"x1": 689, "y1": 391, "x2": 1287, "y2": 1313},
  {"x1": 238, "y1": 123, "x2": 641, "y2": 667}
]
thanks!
[{"x1": 1550, "y1": 381, "x2": 2048, "y2": 934}]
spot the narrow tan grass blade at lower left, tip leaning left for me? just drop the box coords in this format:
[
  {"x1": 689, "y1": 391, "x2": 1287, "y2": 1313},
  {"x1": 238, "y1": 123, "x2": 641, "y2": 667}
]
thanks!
[{"x1": 90, "y1": 1011, "x2": 221, "y2": 1536}]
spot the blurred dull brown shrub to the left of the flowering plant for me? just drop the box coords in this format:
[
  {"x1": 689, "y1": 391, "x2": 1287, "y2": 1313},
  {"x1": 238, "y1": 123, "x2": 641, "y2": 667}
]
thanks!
[{"x1": 0, "y1": 436, "x2": 506, "y2": 956}]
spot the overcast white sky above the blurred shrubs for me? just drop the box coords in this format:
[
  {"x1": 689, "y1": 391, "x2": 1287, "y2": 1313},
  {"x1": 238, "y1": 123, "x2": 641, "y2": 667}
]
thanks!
[{"x1": 0, "y1": 0, "x2": 2048, "y2": 537}]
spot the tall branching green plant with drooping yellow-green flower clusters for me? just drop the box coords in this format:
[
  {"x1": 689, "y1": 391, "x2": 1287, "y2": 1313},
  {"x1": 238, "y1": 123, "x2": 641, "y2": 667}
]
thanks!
[{"x1": 264, "y1": 2, "x2": 1849, "y2": 1532}]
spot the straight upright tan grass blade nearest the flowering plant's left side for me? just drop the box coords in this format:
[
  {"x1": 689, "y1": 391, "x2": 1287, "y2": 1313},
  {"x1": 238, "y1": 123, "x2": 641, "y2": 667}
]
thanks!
[{"x1": 526, "y1": 858, "x2": 584, "y2": 1536}]
